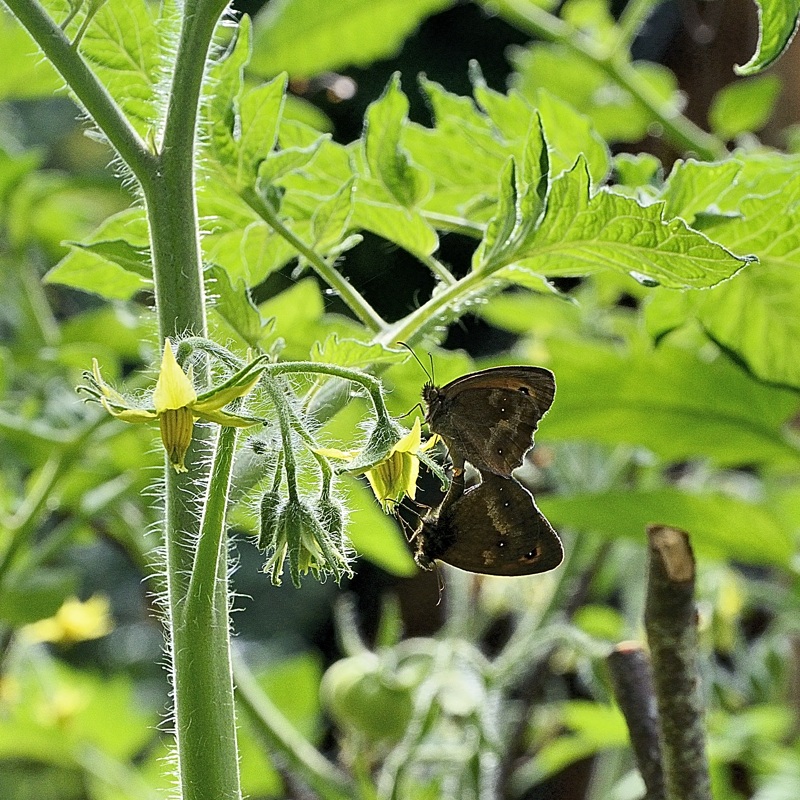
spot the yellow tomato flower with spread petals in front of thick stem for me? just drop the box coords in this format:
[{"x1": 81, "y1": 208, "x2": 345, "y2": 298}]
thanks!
[{"x1": 82, "y1": 339, "x2": 264, "y2": 472}]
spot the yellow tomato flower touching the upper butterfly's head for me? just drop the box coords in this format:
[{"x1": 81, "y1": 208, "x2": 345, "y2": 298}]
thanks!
[{"x1": 316, "y1": 418, "x2": 435, "y2": 514}]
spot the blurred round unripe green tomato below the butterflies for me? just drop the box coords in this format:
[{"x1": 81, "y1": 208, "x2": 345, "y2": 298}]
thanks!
[{"x1": 321, "y1": 652, "x2": 414, "y2": 742}]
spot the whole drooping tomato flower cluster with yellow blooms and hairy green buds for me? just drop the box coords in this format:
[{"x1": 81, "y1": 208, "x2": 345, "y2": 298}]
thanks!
[{"x1": 81, "y1": 339, "x2": 435, "y2": 585}]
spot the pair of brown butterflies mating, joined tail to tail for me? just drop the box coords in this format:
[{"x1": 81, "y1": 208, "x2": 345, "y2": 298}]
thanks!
[{"x1": 414, "y1": 367, "x2": 564, "y2": 575}]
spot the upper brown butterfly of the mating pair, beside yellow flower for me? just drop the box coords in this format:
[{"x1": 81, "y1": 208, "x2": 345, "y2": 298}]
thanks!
[{"x1": 423, "y1": 367, "x2": 556, "y2": 476}]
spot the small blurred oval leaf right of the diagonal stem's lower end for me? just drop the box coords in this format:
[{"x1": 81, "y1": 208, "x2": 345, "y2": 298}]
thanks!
[{"x1": 708, "y1": 75, "x2": 781, "y2": 141}]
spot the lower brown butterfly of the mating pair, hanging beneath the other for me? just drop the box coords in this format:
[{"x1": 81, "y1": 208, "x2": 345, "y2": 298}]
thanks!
[{"x1": 417, "y1": 474, "x2": 564, "y2": 576}]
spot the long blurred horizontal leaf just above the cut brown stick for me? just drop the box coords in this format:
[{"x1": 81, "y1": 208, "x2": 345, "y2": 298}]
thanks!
[{"x1": 537, "y1": 488, "x2": 794, "y2": 567}]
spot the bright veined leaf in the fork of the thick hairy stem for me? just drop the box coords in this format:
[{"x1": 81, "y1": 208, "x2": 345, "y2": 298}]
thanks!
[{"x1": 80, "y1": 0, "x2": 163, "y2": 137}]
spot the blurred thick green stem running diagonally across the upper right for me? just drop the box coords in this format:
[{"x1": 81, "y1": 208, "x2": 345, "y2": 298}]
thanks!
[{"x1": 479, "y1": 0, "x2": 727, "y2": 161}]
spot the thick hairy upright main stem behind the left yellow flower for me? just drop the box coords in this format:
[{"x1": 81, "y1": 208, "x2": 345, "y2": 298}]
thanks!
[{"x1": 142, "y1": 0, "x2": 241, "y2": 800}]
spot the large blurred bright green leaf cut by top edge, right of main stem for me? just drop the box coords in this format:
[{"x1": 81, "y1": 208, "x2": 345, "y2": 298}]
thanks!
[{"x1": 250, "y1": 0, "x2": 453, "y2": 78}]
